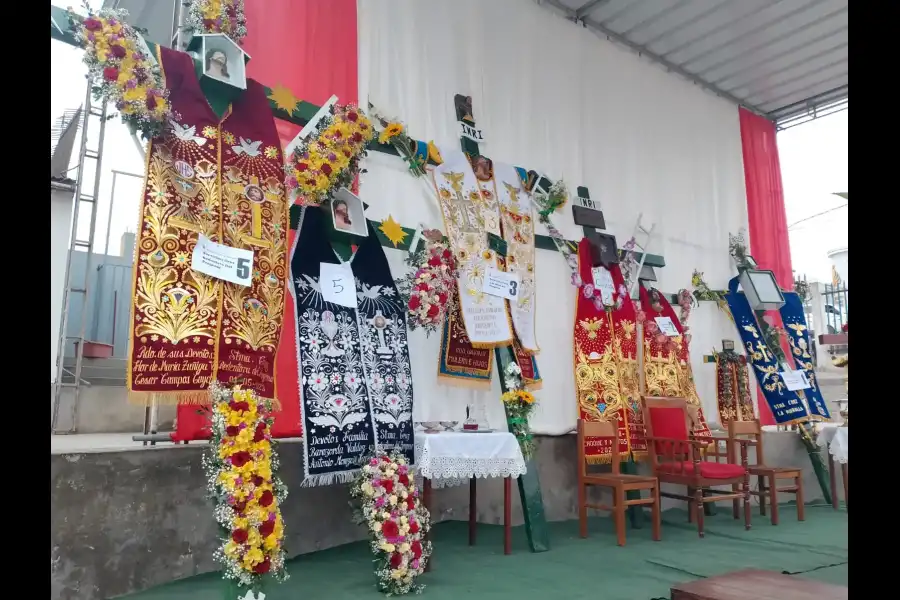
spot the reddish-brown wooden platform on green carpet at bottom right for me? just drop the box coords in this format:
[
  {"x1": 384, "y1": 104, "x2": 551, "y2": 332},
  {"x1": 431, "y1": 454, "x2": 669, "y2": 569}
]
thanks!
[{"x1": 671, "y1": 569, "x2": 850, "y2": 600}]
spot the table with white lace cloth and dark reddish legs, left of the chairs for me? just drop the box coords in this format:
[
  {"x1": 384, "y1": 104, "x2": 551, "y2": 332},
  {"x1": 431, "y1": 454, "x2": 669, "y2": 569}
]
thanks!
[{"x1": 416, "y1": 431, "x2": 526, "y2": 570}]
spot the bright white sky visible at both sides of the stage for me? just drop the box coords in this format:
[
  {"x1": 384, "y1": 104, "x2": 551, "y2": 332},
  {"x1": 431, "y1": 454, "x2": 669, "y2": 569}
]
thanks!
[{"x1": 50, "y1": 7, "x2": 849, "y2": 282}]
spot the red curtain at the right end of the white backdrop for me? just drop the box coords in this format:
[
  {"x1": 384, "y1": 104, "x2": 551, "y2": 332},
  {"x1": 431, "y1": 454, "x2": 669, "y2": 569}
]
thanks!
[{"x1": 739, "y1": 108, "x2": 794, "y2": 425}]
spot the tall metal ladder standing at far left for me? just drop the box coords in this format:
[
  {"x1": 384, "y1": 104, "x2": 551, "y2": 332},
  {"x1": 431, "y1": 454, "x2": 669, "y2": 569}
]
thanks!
[{"x1": 50, "y1": 82, "x2": 106, "y2": 434}]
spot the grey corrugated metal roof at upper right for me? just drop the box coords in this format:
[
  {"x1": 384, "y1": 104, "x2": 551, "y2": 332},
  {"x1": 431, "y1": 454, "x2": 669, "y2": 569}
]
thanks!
[{"x1": 536, "y1": 0, "x2": 849, "y2": 123}]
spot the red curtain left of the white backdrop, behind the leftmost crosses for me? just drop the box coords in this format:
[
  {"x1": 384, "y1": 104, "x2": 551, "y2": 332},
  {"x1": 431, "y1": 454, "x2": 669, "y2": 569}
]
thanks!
[{"x1": 173, "y1": 0, "x2": 358, "y2": 440}]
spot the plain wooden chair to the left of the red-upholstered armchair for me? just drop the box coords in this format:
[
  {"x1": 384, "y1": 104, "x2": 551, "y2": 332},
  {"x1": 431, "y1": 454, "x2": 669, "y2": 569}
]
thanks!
[{"x1": 578, "y1": 419, "x2": 661, "y2": 546}]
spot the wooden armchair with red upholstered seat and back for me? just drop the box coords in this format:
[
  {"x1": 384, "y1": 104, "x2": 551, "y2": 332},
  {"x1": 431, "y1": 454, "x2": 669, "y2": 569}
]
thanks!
[{"x1": 641, "y1": 396, "x2": 750, "y2": 537}]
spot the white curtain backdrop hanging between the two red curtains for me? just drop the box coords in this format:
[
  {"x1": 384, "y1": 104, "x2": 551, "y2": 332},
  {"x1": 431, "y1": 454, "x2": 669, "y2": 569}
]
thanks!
[{"x1": 358, "y1": 0, "x2": 747, "y2": 434}]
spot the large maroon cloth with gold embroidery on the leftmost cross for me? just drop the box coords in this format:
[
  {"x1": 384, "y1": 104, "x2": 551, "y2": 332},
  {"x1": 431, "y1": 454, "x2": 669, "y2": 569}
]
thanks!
[{"x1": 127, "y1": 47, "x2": 288, "y2": 403}]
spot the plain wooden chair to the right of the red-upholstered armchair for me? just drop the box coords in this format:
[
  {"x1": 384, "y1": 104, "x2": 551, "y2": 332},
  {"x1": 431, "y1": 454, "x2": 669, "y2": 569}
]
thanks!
[{"x1": 728, "y1": 419, "x2": 804, "y2": 525}]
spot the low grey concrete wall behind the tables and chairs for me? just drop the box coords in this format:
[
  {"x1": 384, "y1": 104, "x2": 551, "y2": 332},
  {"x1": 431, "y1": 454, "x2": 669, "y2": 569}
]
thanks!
[{"x1": 50, "y1": 432, "x2": 840, "y2": 600}]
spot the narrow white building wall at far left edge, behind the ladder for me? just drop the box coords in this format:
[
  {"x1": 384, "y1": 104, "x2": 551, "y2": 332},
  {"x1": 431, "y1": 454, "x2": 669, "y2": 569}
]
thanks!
[{"x1": 50, "y1": 188, "x2": 73, "y2": 383}]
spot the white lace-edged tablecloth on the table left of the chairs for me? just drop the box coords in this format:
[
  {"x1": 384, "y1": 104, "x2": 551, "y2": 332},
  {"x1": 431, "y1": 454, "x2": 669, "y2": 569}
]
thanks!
[{"x1": 416, "y1": 431, "x2": 527, "y2": 487}]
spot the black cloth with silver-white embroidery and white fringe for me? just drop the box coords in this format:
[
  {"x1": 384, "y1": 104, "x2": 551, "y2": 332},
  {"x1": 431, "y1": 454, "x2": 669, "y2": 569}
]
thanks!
[{"x1": 291, "y1": 207, "x2": 415, "y2": 485}]
